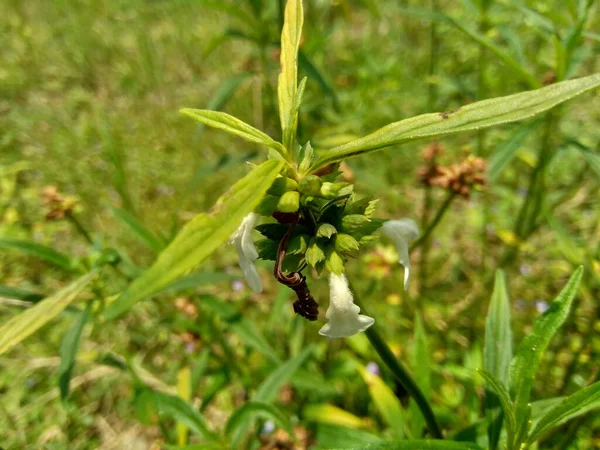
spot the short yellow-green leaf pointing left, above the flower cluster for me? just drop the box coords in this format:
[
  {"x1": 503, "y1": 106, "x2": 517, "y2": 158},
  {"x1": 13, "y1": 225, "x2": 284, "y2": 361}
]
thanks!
[{"x1": 179, "y1": 108, "x2": 283, "y2": 152}]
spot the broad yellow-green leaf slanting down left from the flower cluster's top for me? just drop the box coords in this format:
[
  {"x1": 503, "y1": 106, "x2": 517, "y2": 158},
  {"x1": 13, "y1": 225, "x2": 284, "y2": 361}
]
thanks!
[{"x1": 105, "y1": 160, "x2": 283, "y2": 319}]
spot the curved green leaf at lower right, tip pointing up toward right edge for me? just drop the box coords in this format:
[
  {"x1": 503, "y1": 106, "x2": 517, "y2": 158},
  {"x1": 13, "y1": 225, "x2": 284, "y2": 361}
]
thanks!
[{"x1": 509, "y1": 266, "x2": 583, "y2": 444}]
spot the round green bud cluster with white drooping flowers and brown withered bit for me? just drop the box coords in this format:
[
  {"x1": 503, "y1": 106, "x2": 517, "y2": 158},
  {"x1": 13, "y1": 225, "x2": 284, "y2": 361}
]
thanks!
[{"x1": 231, "y1": 154, "x2": 419, "y2": 338}]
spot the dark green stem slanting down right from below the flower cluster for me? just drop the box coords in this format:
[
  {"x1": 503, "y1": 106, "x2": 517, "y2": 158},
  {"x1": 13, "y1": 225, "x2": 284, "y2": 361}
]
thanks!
[{"x1": 355, "y1": 302, "x2": 444, "y2": 439}]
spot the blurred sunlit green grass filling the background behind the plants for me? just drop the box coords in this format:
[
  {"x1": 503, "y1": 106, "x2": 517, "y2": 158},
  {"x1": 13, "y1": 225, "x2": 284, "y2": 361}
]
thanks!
[{"x1": 0, "y1": 0, "x2": 600, "y2": 449}]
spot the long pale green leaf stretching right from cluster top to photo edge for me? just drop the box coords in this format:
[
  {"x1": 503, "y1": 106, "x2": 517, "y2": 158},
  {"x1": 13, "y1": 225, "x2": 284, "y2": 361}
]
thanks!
[{"x1": 311, "y1": 74, "x2": 600, "y2": 171}]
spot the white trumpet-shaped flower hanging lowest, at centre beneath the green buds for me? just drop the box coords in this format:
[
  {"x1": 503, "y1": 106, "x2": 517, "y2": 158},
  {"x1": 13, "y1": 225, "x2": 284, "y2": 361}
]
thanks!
[{"x1": 319, "y1": 274, "x2": 375, "y2": 339}]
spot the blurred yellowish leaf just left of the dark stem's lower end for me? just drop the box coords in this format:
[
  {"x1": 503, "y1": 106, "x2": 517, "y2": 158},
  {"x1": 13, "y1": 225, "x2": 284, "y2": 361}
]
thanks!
[{"x1": 360, "y1": 368, "x2": 406, "y2": 439}]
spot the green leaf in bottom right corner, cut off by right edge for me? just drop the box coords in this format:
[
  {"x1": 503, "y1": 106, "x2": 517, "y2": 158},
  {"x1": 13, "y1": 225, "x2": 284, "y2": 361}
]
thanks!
[{"x1": 527, "y1": 381, "x2": 600, "y2": 445}]
